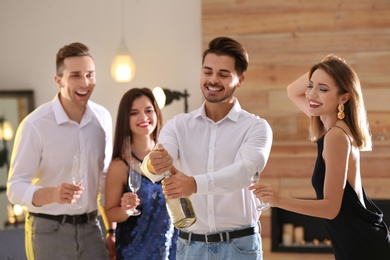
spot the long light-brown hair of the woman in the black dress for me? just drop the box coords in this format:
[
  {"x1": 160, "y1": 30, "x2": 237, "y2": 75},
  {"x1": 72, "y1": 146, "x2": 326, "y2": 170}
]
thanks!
[{"x1": 309, "y1": 54, "x2": 372, "y2": 151}]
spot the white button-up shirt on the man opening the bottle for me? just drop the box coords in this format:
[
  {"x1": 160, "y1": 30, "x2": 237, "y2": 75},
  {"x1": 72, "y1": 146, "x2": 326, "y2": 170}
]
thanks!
[{"x1": 143, "y1": 99, "x2": 272, "y2": 234}]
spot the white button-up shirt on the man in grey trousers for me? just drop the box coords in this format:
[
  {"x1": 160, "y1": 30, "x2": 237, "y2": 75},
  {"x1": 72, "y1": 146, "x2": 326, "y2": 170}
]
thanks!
[{"x1": 7, "y1": 95, "x2": 112, "y2": 215}]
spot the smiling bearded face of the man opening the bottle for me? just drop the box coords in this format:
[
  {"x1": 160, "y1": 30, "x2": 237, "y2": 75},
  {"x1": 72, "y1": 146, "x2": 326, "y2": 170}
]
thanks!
[{"x1": 200, "y1": 53, "x2": 244, "y2": 103}]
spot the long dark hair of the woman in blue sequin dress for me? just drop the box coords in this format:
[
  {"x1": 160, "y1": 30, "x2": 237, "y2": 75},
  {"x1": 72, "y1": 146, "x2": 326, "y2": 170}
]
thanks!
[{"x1": 112, "y1": 88, "x2": 163, "y2": 159}]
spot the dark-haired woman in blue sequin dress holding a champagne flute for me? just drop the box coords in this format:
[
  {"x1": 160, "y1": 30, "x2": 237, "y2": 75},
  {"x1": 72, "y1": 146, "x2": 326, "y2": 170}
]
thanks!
[{"x1": 105, "y1": 88, "x2": 177, "y2": 260}]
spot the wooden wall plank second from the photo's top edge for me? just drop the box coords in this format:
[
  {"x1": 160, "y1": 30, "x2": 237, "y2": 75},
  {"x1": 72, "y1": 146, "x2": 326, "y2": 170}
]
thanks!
[{"x1": 203, "y1": 9, "x2": 390, "y2": 35}]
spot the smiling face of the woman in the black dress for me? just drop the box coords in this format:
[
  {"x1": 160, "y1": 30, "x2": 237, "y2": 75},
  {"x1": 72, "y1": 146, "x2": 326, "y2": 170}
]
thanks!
[{"x1": 306, "y1": 69, "x2": 347, "y2": 118}]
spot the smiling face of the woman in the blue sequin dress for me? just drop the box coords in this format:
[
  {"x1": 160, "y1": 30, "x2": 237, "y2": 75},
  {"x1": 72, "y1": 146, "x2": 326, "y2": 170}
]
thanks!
[{"x1": 129, "y1": 96, "x2": 157, "y2": 137}]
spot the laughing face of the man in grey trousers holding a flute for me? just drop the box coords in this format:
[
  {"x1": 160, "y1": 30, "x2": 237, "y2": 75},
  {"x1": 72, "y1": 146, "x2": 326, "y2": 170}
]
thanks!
[{"x1": 55, "y1": 56, "x2": 96, "y2": 113}]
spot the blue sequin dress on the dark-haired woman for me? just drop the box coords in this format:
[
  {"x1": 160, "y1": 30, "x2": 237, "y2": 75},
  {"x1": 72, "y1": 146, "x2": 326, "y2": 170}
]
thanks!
[{"x1": 116, "y1": 159, "x2": 178, "y2": 260}]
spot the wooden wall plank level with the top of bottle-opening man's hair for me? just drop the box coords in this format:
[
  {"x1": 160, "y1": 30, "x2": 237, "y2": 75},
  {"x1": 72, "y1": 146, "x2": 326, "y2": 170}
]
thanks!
[{"x1": 210, "y1": 29, "x2": 390, "y2": 54}]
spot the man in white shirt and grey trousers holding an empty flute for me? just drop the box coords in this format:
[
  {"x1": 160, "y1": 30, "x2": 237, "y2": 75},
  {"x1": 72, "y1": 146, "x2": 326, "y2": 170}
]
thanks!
[{"x1": 7, "y1": 42, "x2": 114, "y2": 260}]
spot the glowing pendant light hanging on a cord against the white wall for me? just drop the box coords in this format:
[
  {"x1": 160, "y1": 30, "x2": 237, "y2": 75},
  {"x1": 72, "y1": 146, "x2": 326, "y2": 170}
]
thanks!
[{"x1": 111, "y1": 0, "x2": 135, "y2": 82}]
